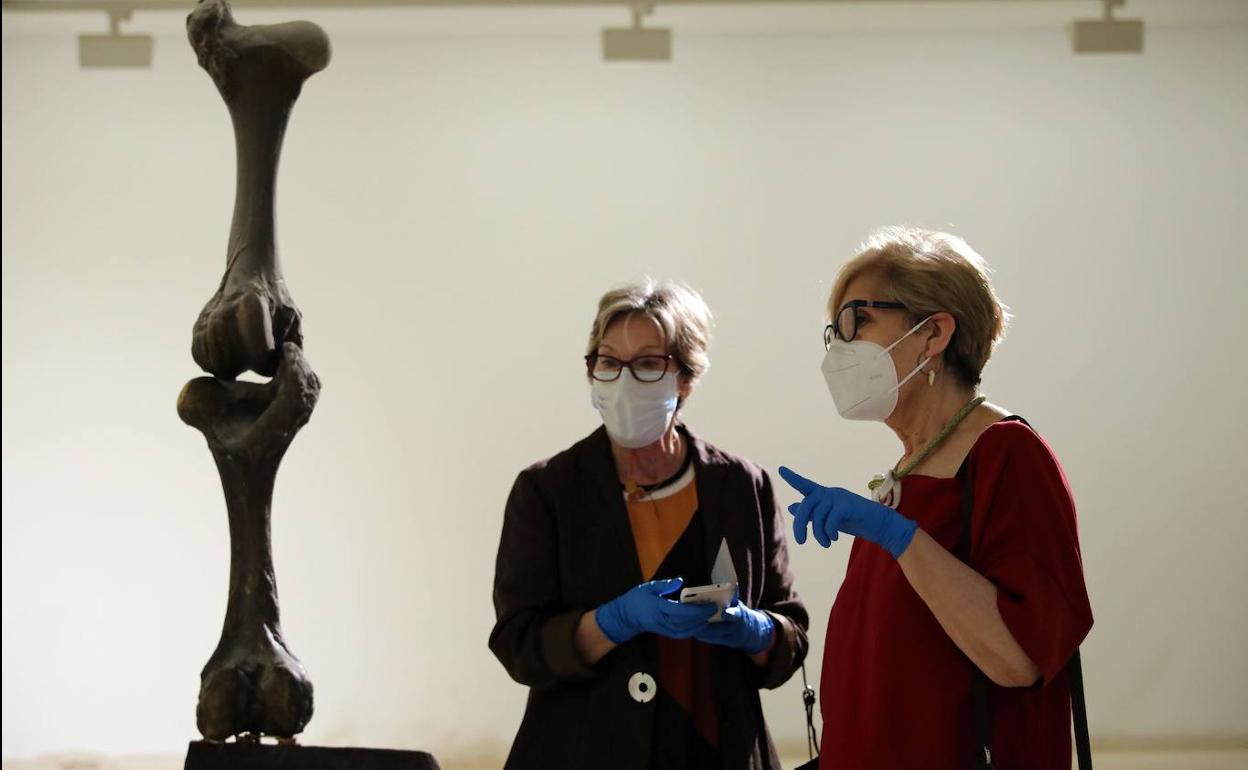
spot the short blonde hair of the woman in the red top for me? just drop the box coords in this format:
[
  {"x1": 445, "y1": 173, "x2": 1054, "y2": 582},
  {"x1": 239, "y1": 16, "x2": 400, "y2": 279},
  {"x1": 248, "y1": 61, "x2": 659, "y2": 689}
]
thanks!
[{"x1": 827, "y1": 226, "x2": 1010, "y2": 388}]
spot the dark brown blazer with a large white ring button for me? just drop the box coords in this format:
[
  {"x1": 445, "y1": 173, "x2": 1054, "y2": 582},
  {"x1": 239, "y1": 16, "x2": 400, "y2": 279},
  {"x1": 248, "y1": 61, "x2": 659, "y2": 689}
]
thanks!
[{"x1": 489, "y1": 428, "x2": 810, "y2": 770}]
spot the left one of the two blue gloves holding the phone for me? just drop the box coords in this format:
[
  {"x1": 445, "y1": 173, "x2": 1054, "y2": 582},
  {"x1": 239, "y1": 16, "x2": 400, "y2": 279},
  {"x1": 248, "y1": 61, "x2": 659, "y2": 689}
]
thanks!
[{"x1": 594, "y1": 578, "x2": 715, "y2": 644}]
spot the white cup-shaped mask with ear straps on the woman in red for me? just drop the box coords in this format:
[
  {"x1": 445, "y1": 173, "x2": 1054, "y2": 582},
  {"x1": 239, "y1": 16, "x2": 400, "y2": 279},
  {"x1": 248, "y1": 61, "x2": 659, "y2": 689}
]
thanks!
[{"x1": 822, "y1": 316, "x2": 931, "y2": 422}]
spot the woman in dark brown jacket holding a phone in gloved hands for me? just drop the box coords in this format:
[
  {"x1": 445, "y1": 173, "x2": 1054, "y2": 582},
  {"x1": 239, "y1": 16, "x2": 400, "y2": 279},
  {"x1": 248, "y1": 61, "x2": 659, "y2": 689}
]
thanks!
[{"x1": 489, "y1": 282, "x2": 809, "y2": 770}]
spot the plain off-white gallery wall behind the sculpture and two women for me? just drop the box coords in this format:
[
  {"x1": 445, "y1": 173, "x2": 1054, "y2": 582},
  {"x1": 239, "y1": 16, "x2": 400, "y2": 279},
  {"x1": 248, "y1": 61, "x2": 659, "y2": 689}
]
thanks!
[{"x1": 2, "y1": 1, "x2": 1248, "y2": 758}]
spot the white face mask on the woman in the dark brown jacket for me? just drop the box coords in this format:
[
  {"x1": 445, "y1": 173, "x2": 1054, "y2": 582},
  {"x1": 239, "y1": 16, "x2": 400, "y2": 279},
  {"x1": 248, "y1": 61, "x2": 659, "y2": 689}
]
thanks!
[{"x1": 589, "y1": 371, "x2": 679, "y2": 449}]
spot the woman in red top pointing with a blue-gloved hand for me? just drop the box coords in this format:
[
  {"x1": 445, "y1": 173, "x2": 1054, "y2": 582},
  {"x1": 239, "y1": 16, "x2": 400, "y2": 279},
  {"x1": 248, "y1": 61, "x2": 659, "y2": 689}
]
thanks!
[{"x1": 780, "y1": 228, "x2": 1092, "y2": 770}]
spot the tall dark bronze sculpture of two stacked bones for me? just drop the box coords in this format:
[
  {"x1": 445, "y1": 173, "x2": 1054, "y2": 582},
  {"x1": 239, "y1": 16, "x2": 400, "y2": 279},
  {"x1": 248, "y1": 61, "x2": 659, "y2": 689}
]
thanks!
[{"x1": 177, "y1": 0, "x2": 329, "y2": 741}]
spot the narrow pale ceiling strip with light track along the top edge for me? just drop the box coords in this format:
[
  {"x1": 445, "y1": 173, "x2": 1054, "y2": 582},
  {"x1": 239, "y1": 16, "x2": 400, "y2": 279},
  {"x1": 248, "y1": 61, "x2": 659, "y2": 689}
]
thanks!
[{"x1": 2, "y1": 0, "x2": 1248, "y2": 44}]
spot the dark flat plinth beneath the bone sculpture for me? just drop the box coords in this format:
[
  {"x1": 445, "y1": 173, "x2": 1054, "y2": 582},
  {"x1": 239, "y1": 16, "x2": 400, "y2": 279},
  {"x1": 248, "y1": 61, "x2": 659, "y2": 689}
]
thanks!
[{"x1": 183, "y1": 740, "x2": 439, "y2": 770}]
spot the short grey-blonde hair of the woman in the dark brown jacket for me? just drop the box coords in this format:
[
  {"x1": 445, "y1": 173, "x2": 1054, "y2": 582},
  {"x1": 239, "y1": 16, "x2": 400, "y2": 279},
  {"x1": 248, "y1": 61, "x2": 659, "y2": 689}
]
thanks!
[{"x1": 585, "y1": 278, "x2": 711, "y2": 382}]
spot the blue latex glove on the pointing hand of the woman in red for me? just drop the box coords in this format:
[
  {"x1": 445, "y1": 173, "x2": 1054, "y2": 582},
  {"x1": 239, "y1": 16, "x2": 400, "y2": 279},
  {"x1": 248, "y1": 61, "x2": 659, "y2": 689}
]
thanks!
[{"x1": 780, "y1": 467, "x2": 919, "y2": 559}]
